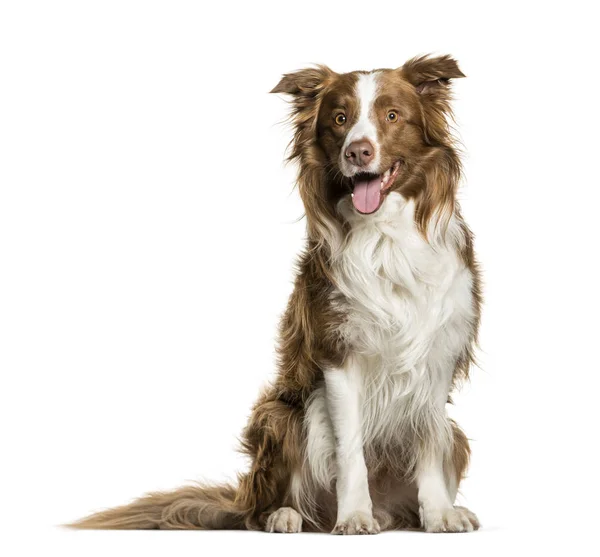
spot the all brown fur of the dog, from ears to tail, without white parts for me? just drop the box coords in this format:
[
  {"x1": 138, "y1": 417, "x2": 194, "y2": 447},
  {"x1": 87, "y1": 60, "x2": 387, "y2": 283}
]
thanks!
[{"x1": 72, "y1": 56, "x2": 481, "y2": 531}]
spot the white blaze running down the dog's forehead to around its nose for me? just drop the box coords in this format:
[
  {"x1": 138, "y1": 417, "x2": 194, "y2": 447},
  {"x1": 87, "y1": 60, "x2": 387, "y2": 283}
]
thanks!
[{"x1": 342, "y1": 72, "x2": 380, "y2": 168}]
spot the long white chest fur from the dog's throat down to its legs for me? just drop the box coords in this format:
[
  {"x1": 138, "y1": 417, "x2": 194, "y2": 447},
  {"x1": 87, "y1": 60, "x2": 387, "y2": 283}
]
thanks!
[{"x1": 334, "y1": 193, "x2": 473, "y2": 438}]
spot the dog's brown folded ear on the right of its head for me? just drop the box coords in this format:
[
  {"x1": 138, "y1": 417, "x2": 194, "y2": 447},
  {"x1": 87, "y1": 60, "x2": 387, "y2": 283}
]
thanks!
[{"x1": 401, "y1": 55, "x2": 465, "y2": 96}]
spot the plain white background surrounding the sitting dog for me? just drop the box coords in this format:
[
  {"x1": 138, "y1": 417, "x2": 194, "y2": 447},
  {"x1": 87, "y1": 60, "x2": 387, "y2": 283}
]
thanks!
[{"x1": 0, "y1": 0, "x2": 600, "y2": 556}]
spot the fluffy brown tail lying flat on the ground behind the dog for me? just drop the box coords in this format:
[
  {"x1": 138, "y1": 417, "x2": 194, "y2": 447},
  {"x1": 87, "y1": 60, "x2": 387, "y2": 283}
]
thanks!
[{"x1": 69, "y1": 485, "x2": 247, "y2": 530}]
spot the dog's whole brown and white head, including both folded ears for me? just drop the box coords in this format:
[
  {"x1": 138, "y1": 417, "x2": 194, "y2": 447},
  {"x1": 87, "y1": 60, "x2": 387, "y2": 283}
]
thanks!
[{"x1": 272, "y1": 56, "x2": 464, "y2": 243}]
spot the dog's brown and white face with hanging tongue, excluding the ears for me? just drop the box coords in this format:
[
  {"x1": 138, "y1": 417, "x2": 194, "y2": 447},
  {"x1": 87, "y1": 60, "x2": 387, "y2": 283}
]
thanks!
[{"x1": 316, "y1": 70, "x2": 423, "y2": 214}]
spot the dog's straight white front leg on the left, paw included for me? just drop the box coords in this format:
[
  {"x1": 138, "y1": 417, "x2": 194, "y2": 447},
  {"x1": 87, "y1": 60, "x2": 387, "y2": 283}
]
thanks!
[{"x1": 325, "y1": 358, "x2": 379, "y2": 534}]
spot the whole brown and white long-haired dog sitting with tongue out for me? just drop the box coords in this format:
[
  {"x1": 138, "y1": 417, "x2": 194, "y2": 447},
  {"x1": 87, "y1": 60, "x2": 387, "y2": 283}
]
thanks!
[{"x1": 74, "y1": 56, "x2": 481, "y2": 534}]
